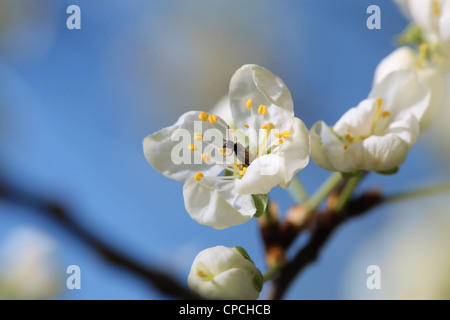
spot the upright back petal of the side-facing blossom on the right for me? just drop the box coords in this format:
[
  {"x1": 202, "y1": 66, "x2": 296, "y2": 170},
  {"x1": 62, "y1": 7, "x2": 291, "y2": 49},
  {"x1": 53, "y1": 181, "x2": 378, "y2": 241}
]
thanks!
[{"x1": 369, "y1": 70, "x2": 431, "y2": 122}]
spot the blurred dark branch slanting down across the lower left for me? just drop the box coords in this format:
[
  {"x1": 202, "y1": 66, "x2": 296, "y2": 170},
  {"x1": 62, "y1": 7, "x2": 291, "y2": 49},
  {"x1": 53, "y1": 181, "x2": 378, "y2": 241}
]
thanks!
[{"x1": 0, "y1": 181, "x2": 199, "y2": 300}]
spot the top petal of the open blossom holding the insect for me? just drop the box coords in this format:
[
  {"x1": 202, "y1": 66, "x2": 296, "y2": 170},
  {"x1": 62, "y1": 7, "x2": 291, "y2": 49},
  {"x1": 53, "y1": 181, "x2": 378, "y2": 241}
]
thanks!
[{"x1": 229, "y1": 65, "x2": 294, "y2": 131}]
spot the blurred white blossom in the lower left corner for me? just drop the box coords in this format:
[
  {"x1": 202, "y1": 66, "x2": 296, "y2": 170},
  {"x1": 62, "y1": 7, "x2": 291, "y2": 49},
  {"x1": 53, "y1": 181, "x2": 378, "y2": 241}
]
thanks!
[{"x1": 0, "y1": 227, "x2": 63, "y2": 300}]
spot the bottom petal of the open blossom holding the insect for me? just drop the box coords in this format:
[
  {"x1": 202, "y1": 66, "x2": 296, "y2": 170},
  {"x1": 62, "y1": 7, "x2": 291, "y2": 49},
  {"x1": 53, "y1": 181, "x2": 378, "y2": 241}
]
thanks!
[{"x1": 183, "y1": 177, "x2": 256, "y2": 229}]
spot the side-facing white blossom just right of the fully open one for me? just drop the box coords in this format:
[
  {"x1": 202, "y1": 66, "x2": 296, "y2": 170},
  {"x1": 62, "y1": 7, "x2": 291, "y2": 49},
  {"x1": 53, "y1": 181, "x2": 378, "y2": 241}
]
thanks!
[{"x1": 310, "y1": 70, "x2": 430, "y2": 172}]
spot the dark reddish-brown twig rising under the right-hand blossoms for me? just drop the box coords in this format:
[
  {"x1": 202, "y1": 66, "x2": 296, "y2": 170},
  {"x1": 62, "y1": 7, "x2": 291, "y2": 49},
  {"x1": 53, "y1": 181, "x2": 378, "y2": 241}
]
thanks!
[{"x1": 268, "y1": 190, "x2": 383, "y2": 299}]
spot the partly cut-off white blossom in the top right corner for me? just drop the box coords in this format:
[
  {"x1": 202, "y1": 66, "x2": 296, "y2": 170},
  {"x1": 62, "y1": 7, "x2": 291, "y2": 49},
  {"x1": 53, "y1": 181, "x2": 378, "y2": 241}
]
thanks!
[{"x1": 395, "y1": 0, "x2": 450, "y2": 67}]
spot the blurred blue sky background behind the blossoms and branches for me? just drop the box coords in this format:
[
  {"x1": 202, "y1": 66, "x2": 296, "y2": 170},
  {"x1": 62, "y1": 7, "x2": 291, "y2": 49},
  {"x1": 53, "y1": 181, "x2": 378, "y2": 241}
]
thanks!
[{"x1": 0, "y1": 0, "x2": 450, "y2": 299}]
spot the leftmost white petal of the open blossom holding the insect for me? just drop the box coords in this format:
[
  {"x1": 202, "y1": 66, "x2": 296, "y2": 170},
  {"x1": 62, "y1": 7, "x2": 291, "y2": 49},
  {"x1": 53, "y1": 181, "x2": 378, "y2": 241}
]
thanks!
[{"x1": 143, "y1": 111, "x2": 226, "y2": 182}]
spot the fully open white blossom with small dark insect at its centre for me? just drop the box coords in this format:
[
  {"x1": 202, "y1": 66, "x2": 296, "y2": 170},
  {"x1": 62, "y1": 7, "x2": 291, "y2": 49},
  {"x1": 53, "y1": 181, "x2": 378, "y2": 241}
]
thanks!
[{"x1": 143, "y1": 65, "x2": 310, "y2": 229}]
